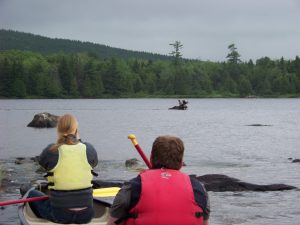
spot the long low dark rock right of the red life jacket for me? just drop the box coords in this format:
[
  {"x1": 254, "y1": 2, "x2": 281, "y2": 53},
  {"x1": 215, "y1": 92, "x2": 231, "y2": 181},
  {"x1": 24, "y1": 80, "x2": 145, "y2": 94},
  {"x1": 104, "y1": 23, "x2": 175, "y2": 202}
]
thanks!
[{"x1": 196, "y1": 174, "x2": 298, "y2": 192}]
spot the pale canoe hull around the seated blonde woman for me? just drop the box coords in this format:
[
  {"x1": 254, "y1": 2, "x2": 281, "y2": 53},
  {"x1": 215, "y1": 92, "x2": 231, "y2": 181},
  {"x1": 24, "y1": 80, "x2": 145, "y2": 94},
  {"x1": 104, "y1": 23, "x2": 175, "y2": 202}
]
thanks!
[{"x1": 18, "y1": 187, "x2": 114, "y2": 225}]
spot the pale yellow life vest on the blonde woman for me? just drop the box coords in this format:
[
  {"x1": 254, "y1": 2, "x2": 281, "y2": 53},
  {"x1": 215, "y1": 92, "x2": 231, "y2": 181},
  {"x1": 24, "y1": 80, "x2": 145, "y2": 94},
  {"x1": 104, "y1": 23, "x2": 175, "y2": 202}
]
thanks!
[{"x1": 48, "y1": 143, "x2": 93, "y2": 190}]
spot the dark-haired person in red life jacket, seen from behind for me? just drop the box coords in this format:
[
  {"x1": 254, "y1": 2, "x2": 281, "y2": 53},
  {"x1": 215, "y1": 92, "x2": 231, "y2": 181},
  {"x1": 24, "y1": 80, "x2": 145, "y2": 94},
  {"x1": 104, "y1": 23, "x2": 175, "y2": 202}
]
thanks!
[{"x1": 107, "y1": 136, "x2": 210, "y2": 225}]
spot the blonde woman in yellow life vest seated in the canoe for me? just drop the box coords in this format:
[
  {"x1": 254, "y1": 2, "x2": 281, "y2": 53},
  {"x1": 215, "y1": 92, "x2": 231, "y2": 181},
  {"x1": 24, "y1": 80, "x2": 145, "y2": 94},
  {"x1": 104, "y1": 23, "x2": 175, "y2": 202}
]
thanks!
[{"x1": 28, "y1": 114, "x2": 98, "y2": 224}]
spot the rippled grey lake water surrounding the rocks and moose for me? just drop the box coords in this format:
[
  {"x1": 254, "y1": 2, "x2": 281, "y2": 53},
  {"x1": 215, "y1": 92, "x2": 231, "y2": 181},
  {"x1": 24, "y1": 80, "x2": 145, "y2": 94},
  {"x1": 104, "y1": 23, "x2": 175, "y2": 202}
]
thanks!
[{"x1": 0, "y1": 99, "x2": 300, "y2": 225}]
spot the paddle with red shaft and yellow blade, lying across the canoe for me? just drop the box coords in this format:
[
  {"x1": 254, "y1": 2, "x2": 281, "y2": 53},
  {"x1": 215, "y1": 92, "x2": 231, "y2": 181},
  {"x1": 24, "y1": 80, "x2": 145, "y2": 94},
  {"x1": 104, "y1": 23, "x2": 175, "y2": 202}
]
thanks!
[{"x1": 0, "y1": 187, "x2": 120, "y2": 206}]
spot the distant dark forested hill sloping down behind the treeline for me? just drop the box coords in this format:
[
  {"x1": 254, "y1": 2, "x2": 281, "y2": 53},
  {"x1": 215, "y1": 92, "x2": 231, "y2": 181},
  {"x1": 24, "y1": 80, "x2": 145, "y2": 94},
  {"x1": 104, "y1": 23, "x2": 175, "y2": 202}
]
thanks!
[{"x1": 0, "y1": 29, "x2": 171, "y2": 60}]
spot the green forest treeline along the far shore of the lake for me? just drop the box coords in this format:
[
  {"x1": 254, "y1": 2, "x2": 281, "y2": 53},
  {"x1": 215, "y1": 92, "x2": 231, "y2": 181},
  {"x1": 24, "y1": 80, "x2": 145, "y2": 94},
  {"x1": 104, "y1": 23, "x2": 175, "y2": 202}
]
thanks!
[{"x1": 0, "y1": 50, "x2": 300, "y2": 98}]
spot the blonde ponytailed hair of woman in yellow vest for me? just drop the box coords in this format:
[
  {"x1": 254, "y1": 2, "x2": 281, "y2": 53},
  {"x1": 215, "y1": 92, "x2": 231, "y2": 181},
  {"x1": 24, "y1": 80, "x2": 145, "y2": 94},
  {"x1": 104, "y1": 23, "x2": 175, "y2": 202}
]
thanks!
[{"x1": 51, "y1": 114, "x2": 78, "y2": 151}]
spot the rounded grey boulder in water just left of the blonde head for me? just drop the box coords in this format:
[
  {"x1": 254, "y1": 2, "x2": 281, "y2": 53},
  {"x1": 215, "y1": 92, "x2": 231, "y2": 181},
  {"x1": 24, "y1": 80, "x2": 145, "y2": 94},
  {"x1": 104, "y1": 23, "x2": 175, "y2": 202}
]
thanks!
[{"x1": 27, "y1": 112, "x2": 59, "y2": 128}]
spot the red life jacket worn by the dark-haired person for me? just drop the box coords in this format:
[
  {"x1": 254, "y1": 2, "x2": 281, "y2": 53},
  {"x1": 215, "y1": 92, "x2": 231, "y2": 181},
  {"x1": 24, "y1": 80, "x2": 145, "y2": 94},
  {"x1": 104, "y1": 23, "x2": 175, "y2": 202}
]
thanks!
[{"x1": 125, "y1": 169, "x2": 203, "y2": 225}]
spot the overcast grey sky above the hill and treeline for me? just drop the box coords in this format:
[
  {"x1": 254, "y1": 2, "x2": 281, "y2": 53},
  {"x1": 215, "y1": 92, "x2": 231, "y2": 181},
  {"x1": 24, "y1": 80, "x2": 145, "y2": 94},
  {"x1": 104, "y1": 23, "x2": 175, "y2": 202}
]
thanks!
[{"x1": 0, "y1": 0, "x2": 300, "y2": 61}]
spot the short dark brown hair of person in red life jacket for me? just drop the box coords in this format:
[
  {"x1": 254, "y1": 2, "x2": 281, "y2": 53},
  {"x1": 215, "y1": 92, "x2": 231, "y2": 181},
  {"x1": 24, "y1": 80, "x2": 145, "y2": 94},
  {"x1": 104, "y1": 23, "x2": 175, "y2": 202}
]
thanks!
[{"x1": 151, "y1": 135, "x2": 184, "y2": 170}]
